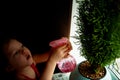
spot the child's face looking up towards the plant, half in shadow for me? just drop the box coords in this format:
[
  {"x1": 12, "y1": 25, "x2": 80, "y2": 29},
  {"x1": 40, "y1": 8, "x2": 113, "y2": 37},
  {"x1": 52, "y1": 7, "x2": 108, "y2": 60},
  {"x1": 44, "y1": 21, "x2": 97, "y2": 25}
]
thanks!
[{"x1": 4, "y1": 39, "x2": 33, "y2": 68}]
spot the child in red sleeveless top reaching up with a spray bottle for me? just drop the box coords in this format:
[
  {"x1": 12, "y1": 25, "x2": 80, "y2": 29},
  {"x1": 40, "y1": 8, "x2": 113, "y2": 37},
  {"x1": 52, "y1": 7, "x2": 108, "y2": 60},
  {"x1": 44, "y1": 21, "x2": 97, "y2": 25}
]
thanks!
[{"x1": 0, "y1": 39, "x2": 71, "y2": 80}]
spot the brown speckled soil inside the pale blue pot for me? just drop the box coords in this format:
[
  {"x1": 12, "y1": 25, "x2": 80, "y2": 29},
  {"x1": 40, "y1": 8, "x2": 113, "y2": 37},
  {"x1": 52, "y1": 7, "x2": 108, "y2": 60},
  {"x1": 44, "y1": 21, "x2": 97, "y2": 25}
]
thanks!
[{"x1": 78, "y1": 61, "x2": 106, "y2": 80}]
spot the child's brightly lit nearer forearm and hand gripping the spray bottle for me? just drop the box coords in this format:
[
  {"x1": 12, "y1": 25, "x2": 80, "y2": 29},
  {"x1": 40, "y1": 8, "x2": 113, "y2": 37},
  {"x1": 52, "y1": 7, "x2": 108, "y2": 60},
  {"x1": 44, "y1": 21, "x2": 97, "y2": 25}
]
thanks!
[{"x1": 40, "y1": 44, "x2": 68, "y2": 80}]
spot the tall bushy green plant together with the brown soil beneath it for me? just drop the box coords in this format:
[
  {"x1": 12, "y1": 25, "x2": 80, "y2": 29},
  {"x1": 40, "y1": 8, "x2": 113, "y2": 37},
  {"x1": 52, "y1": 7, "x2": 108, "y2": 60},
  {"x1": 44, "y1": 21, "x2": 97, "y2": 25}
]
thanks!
[{"x1": 71, "y1": 0, "x2": 120, "y2": 80}]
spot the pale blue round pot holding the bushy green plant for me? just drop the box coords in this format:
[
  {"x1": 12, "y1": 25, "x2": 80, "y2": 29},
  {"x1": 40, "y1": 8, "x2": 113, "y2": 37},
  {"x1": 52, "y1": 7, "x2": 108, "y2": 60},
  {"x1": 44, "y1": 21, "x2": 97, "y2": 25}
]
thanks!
[{"x1": 70, "y1": 61, "x2": 112, "y2": 80}]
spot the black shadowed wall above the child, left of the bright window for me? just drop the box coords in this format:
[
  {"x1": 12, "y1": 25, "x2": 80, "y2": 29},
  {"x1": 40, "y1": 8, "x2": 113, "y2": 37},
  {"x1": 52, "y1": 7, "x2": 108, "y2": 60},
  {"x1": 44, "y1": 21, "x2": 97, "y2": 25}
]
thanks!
[{"x1": 0, "y1": 0, "x2": 72, "y2": 53}]
